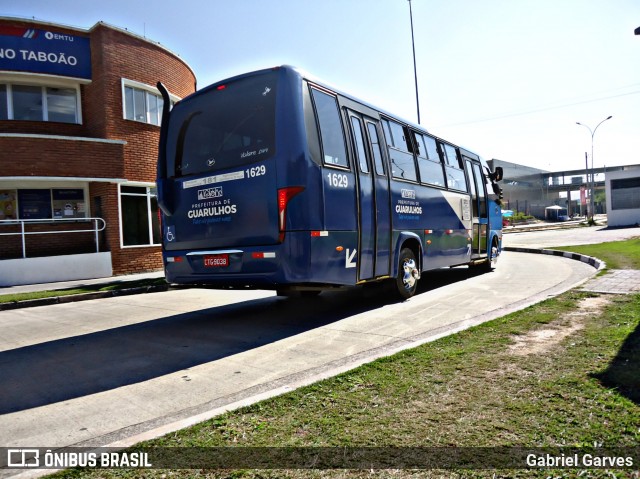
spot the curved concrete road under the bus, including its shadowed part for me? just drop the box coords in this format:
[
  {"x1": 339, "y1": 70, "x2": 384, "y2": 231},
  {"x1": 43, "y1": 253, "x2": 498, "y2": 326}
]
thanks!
[{"x1": 0, "y1": 252, "x2": 595, "y2": 458}]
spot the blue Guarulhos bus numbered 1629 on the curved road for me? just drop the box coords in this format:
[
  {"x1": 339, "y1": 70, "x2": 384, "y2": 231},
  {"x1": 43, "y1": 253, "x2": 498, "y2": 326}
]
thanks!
[{"x1": 157, "y1": 66, "x2": 502, "y2": 298}]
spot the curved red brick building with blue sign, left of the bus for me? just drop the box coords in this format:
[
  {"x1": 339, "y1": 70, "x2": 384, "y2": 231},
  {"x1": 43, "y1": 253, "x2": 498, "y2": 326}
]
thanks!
[{"x1": 0, "y1": 18, "x2": 196, "y2": 286}]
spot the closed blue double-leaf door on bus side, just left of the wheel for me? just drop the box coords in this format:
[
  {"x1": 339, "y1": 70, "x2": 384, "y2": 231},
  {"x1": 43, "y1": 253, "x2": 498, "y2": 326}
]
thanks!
[{"x1": 348, "y1": 110, "x2": 391, "y2": 281}]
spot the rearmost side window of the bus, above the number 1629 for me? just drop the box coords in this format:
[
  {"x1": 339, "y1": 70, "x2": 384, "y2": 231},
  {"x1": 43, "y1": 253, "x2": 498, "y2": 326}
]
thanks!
[{"x1": 311, "y1": 88, "x2": 349, "y2": 168}]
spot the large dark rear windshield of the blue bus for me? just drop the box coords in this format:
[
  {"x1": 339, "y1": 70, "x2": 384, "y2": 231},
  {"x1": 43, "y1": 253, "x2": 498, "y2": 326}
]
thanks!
[{"x1": 166, "y1": 72, "x2": 277, "y2": 177}]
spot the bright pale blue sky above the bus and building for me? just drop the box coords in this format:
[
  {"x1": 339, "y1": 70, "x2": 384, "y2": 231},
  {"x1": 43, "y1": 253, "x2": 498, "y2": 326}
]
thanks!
[{"x1": 0, "y1": 0, "x2": 640, "y2": 171}]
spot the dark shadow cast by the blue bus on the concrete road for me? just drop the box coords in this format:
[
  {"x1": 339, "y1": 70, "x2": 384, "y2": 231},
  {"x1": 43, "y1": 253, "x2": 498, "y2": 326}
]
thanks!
[{"x1": 0, "y1": 268, "x2": 490, "y2": 414}]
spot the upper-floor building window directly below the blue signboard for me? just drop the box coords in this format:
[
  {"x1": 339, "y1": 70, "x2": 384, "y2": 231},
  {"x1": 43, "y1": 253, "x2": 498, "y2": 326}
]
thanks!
[{"x1": 0, "y1": 83, "x2": 80, "y2": 123}]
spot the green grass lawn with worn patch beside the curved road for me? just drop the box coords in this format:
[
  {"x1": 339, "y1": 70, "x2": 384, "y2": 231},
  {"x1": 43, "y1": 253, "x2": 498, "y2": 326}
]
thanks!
[{"x1": 36, "y1": 242, "x2": 640, "y2": 479}]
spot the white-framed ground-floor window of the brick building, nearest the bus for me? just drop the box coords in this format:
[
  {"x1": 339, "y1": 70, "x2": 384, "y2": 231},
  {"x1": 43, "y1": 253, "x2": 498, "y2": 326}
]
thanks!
[{"x1": 120, "y1": 185, "x2": 160, "y2": 246}]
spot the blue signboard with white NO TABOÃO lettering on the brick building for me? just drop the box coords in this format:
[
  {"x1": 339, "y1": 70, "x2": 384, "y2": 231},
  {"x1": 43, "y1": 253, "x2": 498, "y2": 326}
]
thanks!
[{"x1": 0, "y1": 26, "x2": 91, "y2": 79}]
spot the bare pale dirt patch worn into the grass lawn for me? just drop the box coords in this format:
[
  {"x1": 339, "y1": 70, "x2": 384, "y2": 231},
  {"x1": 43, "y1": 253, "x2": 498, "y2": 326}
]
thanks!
[{"x1": 509, "y1": 296, "x2": 609, "y2": 356}]
